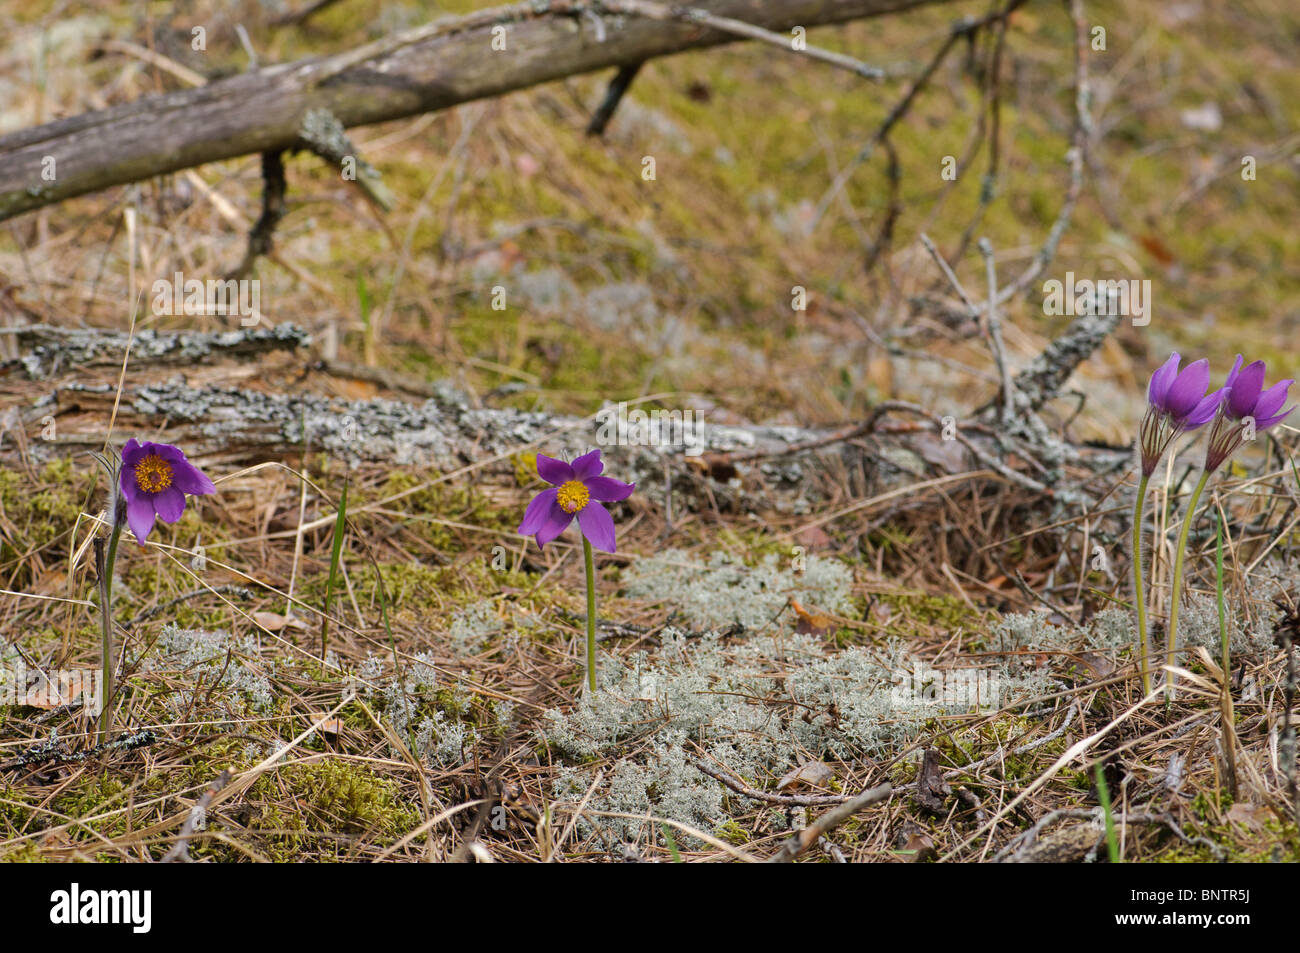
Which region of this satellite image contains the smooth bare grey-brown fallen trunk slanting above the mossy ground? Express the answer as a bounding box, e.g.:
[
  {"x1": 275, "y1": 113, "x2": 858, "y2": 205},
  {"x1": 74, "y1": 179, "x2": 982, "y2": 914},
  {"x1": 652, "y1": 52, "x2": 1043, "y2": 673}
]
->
[{"x1": 0, "y1": 0, "x2": 946, "y2": 220}]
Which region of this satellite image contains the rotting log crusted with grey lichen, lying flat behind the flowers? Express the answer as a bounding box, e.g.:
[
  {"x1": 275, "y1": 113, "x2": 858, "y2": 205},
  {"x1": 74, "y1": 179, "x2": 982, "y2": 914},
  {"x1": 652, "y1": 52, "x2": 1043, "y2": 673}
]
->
[{"x1": 0, "y1": 308, "x2": 1130, "y2": 510}]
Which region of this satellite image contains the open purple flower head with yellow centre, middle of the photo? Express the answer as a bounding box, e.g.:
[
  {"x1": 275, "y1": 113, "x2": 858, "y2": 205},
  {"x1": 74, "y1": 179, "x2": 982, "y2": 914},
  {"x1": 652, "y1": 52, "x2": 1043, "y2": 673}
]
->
[{"x1": 519, "y1": 450, "x2": 637, "y2": 553}]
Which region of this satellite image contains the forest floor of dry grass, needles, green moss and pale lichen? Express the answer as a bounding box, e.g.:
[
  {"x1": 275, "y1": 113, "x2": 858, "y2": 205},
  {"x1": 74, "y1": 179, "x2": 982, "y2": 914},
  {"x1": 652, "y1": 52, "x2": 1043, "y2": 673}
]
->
[{"x1": 0, "y1": 0, "x2": 1300, "y2": 862}]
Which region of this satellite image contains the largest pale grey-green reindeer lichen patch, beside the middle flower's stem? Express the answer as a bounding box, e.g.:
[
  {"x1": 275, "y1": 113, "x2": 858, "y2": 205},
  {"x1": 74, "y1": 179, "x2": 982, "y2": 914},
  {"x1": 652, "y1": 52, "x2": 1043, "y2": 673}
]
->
[{"x1": 540, "y1": 551, "x2": 1054, "y2": 839}]
